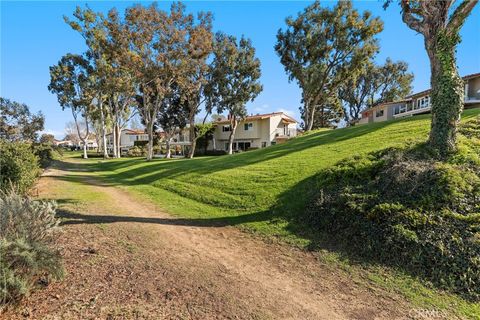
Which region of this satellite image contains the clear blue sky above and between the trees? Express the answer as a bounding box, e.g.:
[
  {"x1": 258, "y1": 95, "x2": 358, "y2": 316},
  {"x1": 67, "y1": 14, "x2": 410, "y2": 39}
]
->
[{"x1": 0, "y1": 1, "x2": 480, "y2": 138}]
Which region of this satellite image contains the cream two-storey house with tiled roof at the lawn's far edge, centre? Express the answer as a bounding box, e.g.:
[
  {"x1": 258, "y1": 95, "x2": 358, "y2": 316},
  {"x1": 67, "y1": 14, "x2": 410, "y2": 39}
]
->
[{"x1": 213, "y1": 112, "x2": 297, "y2": 151}]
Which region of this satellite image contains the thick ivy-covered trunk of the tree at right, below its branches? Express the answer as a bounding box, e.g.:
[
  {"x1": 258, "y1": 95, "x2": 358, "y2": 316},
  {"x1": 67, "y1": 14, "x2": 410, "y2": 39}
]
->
[{"x1": 425, "y1": 32, "x2": 464, "y2": 155}]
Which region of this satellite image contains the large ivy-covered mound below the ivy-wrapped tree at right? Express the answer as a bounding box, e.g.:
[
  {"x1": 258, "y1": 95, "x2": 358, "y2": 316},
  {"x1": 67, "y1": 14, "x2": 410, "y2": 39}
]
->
[{"x1": 307, "y1": 117, "x2": 480, "y2": 300}]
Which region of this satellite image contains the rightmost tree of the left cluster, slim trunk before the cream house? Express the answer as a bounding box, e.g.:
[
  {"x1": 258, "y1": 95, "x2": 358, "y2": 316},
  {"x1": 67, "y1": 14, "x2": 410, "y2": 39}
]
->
[{"x1": 206, "y1": 33, "x2": 263, "y2": 154}]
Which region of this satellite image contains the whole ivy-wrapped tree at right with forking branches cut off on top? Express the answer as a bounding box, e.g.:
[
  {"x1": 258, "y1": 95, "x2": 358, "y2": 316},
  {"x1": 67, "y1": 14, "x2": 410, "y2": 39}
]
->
[{"x1": 386, "y1": 0, "x2": 478, "y2": 154}]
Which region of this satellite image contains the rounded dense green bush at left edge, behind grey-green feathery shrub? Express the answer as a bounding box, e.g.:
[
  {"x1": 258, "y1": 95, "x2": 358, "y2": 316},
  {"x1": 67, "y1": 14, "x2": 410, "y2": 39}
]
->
[{"x1": 0, "y1": 140, "x2": 40, "y2": 194}]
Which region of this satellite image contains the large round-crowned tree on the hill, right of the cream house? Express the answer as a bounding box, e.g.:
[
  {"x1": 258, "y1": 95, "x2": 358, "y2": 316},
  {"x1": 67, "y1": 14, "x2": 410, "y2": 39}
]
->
[{"x1": 275, "y1": 1, "x2": 383, "y2": 130}]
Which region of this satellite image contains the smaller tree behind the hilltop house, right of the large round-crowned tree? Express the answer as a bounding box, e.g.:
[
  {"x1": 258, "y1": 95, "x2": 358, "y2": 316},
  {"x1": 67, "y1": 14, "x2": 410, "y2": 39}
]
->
[{"x1": 339, "y1": 58, "x2": 413, "y2": 125}]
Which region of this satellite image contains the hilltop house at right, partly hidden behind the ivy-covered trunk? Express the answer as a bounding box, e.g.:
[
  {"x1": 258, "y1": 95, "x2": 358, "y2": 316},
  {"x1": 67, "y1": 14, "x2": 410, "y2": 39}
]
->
[{"x1": 358, "y1": 73, "x2": 480, "y2": 124}]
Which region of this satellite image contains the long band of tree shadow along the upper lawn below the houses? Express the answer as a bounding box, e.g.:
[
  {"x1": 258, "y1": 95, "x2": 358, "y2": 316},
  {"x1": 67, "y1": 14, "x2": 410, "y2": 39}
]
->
[{"x1": 60, "y1": 119, "x2": 410, "y2": 185}]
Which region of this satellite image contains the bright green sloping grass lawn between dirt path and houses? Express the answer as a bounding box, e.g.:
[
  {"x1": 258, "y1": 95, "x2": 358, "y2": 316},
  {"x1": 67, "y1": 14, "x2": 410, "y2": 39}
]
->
[{"x1": 65, "y1": 109, "x2": 480, "y2": 318}]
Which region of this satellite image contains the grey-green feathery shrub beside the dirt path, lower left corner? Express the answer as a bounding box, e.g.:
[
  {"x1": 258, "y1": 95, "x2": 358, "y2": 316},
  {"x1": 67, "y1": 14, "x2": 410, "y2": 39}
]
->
[{"x1": 0, "y1": 191, "x2": 64, "y2": 303}]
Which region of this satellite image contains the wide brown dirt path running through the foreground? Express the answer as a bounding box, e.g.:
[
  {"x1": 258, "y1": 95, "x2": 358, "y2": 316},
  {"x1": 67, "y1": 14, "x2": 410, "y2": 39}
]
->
[{"x1": 0, "y1": 162, "x2": 416, "y2": 319}]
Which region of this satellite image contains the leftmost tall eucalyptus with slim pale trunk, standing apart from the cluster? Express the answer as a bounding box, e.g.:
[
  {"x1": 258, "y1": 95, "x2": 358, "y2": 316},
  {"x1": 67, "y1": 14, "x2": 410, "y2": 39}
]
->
[{"x1": 48, "y1": 54, "x2": 92, "y2": 158}]
